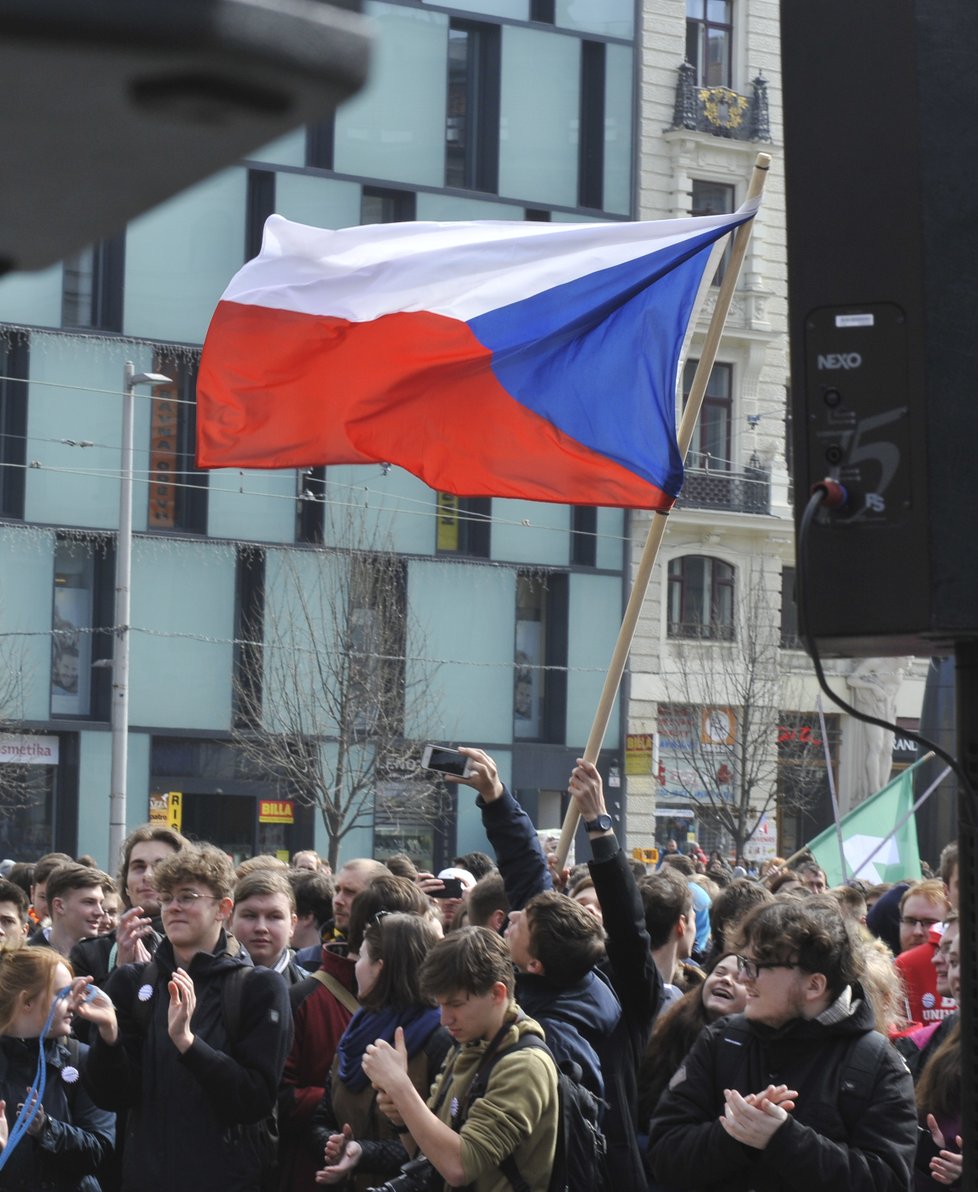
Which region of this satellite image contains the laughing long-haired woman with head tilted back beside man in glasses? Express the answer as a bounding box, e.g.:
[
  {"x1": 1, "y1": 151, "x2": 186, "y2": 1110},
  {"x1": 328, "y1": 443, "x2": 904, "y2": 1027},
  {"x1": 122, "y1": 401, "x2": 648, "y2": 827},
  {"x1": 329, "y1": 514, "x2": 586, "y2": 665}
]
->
[{"x1": 638, "y1": 952, "x2": 747, "y2": 1126}]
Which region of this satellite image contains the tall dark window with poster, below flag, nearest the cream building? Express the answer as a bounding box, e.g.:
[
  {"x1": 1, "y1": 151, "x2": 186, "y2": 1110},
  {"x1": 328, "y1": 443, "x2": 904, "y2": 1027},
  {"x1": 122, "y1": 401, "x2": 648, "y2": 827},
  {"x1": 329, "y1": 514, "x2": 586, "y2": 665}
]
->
[{"x1": 513, "y1": 573, "x2": 568, "y2": 741}]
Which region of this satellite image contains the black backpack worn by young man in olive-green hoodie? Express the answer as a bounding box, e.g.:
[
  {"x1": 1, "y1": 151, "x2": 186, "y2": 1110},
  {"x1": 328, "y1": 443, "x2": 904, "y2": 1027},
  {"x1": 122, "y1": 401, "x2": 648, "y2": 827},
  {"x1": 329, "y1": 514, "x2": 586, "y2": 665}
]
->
[{"x1": 466, "y1": 1035, "x2": 610, "y2": 1192}]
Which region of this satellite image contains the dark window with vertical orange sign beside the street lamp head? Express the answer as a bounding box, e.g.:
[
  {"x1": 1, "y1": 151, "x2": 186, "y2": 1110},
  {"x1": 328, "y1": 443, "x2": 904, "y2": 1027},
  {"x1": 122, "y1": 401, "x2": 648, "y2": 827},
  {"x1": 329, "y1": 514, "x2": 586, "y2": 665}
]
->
[{"x1": 147, "y1": 352, "x2": 208, "y2": 534}]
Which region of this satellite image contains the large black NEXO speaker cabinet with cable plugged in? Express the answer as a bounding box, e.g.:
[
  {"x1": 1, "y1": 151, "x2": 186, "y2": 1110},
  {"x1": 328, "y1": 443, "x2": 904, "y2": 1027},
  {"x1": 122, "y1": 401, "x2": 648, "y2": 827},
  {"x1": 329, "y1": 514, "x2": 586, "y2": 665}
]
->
[{"x1": 781, "y1": 0, "x2": 978, "y2": 656}]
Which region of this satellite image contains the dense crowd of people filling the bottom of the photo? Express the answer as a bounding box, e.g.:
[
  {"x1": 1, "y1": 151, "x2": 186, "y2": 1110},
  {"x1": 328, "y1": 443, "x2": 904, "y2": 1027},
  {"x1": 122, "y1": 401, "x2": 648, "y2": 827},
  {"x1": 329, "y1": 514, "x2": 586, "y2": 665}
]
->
[{"x1": 0, "y1": 749, "x2": 962, "y2": 1192}]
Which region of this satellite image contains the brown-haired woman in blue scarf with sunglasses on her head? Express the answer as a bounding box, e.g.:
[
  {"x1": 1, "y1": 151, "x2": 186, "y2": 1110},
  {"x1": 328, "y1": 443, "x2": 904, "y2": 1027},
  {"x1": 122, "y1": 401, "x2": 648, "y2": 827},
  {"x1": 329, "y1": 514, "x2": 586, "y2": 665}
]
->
[{"x1": 312, "y1": 911, "x2": 452, "y2": 1192}]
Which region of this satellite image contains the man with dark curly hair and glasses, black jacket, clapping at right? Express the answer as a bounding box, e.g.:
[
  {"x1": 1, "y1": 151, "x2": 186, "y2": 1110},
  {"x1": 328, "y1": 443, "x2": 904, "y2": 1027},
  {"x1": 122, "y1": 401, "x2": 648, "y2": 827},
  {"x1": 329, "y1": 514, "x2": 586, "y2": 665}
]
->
[{"x1": 649, "y1": 900, "x2": 917, "y2": 1192}]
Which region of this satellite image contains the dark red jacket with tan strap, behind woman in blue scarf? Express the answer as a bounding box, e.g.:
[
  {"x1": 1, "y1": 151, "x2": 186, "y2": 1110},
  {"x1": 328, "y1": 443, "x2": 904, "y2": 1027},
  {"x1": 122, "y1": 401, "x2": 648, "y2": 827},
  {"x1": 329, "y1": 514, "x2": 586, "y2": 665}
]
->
[{"x1": 278, "y1": 944, "x2": 355, "y2": 1192}]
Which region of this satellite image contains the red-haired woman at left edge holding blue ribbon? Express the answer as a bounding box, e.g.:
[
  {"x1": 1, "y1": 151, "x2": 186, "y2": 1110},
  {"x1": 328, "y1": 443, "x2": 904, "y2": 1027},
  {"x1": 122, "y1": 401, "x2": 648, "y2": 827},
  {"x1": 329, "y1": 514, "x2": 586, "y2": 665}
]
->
[{"x1": 0, "y1": 948, "x2": 116, "y2": 1192}]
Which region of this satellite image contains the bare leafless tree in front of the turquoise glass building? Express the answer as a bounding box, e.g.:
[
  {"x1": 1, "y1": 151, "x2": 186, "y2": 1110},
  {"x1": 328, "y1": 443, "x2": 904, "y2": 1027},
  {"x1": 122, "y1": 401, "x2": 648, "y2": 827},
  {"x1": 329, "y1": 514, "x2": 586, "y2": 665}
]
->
[{"x1": 233, "y1": 503, "x2": 445, "y2": 864}]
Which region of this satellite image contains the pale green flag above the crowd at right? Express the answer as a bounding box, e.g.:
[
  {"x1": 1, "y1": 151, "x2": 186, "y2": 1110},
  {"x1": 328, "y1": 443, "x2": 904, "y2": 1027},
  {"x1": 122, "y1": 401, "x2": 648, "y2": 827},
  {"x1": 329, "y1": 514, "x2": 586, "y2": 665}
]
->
[{"x1": 807, "y1": 763, "x2": 921, "y2": 886}]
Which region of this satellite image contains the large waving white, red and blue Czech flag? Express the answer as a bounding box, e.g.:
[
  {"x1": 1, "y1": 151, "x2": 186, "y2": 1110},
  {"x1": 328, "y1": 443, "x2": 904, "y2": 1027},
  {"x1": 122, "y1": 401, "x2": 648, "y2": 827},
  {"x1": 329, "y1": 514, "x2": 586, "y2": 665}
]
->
[{"x1": 197, "y1": 201, "x2": 757, "y2": 510}]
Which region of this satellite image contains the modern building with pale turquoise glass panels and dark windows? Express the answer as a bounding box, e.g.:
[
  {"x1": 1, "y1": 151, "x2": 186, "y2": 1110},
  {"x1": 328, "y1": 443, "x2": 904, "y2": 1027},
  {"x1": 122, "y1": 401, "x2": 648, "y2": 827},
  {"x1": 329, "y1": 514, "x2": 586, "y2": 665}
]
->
[{"x1": 0, "y1": 0, "x2": 637, "y2": 867}]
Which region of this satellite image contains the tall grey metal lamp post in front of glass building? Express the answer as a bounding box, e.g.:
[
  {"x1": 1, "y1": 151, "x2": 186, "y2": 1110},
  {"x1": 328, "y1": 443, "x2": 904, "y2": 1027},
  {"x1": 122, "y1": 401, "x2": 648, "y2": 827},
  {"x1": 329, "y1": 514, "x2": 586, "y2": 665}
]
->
[{"x1": 109, "y1": 360, "x2": 169, "y2": 868}]
